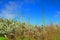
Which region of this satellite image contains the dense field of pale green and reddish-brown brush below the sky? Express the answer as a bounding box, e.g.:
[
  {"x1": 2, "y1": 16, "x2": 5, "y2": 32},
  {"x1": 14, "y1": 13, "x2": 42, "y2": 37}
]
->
[{"x1": 0, "y1": 18, "x2": 60, "y2": 40}]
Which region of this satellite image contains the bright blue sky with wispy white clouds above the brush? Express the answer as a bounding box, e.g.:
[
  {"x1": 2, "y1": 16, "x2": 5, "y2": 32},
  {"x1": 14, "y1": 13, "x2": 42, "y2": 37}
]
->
[{"x1": 0, "y1": 0, "x2": 60, "y2": 25}]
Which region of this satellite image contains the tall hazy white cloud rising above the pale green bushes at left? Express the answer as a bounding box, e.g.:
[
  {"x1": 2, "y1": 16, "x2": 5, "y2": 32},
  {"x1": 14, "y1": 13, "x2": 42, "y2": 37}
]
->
[{"x1": 0, "y1": 1, "x2": 17, "y2": 19}]
